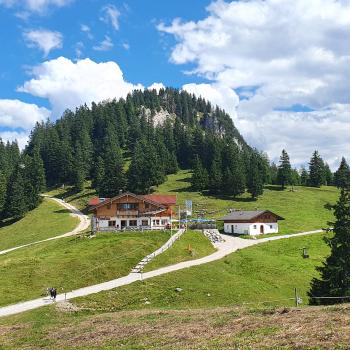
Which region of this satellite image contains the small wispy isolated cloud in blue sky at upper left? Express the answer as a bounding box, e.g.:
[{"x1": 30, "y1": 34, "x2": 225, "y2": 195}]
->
[{"x1": 23, "y1": 29, "x2": 63, "y2": 57}]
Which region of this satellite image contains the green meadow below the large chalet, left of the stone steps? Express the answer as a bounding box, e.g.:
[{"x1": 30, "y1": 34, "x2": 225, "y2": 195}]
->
[{"x1": 0, "y1": 231, "x2": 169, "y2": 306}]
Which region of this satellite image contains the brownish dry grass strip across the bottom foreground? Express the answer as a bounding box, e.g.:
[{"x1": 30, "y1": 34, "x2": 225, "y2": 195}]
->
[{"x1": 0, "y1": 305, "x2": 350, "y2": 350}]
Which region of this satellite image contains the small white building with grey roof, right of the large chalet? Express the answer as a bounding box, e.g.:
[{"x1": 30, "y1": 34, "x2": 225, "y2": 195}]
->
[{"x1": 221, "y1": 210, "x2": 284, "y2": 236}]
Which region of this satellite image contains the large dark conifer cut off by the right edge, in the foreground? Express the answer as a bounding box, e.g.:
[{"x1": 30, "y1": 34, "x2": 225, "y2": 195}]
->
[{"x1": 309, "y1": 188, "x2": 350, "y2": 304}]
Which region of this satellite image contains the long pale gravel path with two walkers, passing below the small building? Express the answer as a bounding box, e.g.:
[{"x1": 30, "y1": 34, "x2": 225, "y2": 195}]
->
[{"x1": 0, "y1": 230, "x2": 322, "y2": 317}]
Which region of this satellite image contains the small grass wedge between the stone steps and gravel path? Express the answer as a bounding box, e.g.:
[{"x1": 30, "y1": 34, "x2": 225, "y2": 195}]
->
[{"x1": 144, "y1": 230, "x2": 215, "y2": 271}]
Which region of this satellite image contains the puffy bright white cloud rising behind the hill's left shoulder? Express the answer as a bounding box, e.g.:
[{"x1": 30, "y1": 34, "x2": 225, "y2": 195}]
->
[{"x1": 18, "y1": 57, "x2": 143, "y2": 118}]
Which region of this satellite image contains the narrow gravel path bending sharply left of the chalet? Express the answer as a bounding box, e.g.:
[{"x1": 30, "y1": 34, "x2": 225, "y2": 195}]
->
[{"x1": 0, "y1": 196, "x2": 90, "y2": 255}]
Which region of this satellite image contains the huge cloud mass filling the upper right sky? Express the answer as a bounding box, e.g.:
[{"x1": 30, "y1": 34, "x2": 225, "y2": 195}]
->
[{"x1": 158, "y1": 0, "x2": 350, "y2": 168}]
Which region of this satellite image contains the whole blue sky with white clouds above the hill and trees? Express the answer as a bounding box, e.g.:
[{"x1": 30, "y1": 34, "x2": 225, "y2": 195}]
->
[{"x1": 0, "y1": 0, "x2": 350, "y2": 168}]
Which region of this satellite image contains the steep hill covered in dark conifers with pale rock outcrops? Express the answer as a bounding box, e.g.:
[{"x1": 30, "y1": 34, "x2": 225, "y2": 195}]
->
[{"x1": 25, "y1": 88, "x2": 269, "y2": 197}]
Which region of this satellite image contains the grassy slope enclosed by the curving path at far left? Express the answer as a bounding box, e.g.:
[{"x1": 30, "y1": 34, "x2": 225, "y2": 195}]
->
[{"x1": 0, "y1": 199, "x2": 79, "y2": 250}]
